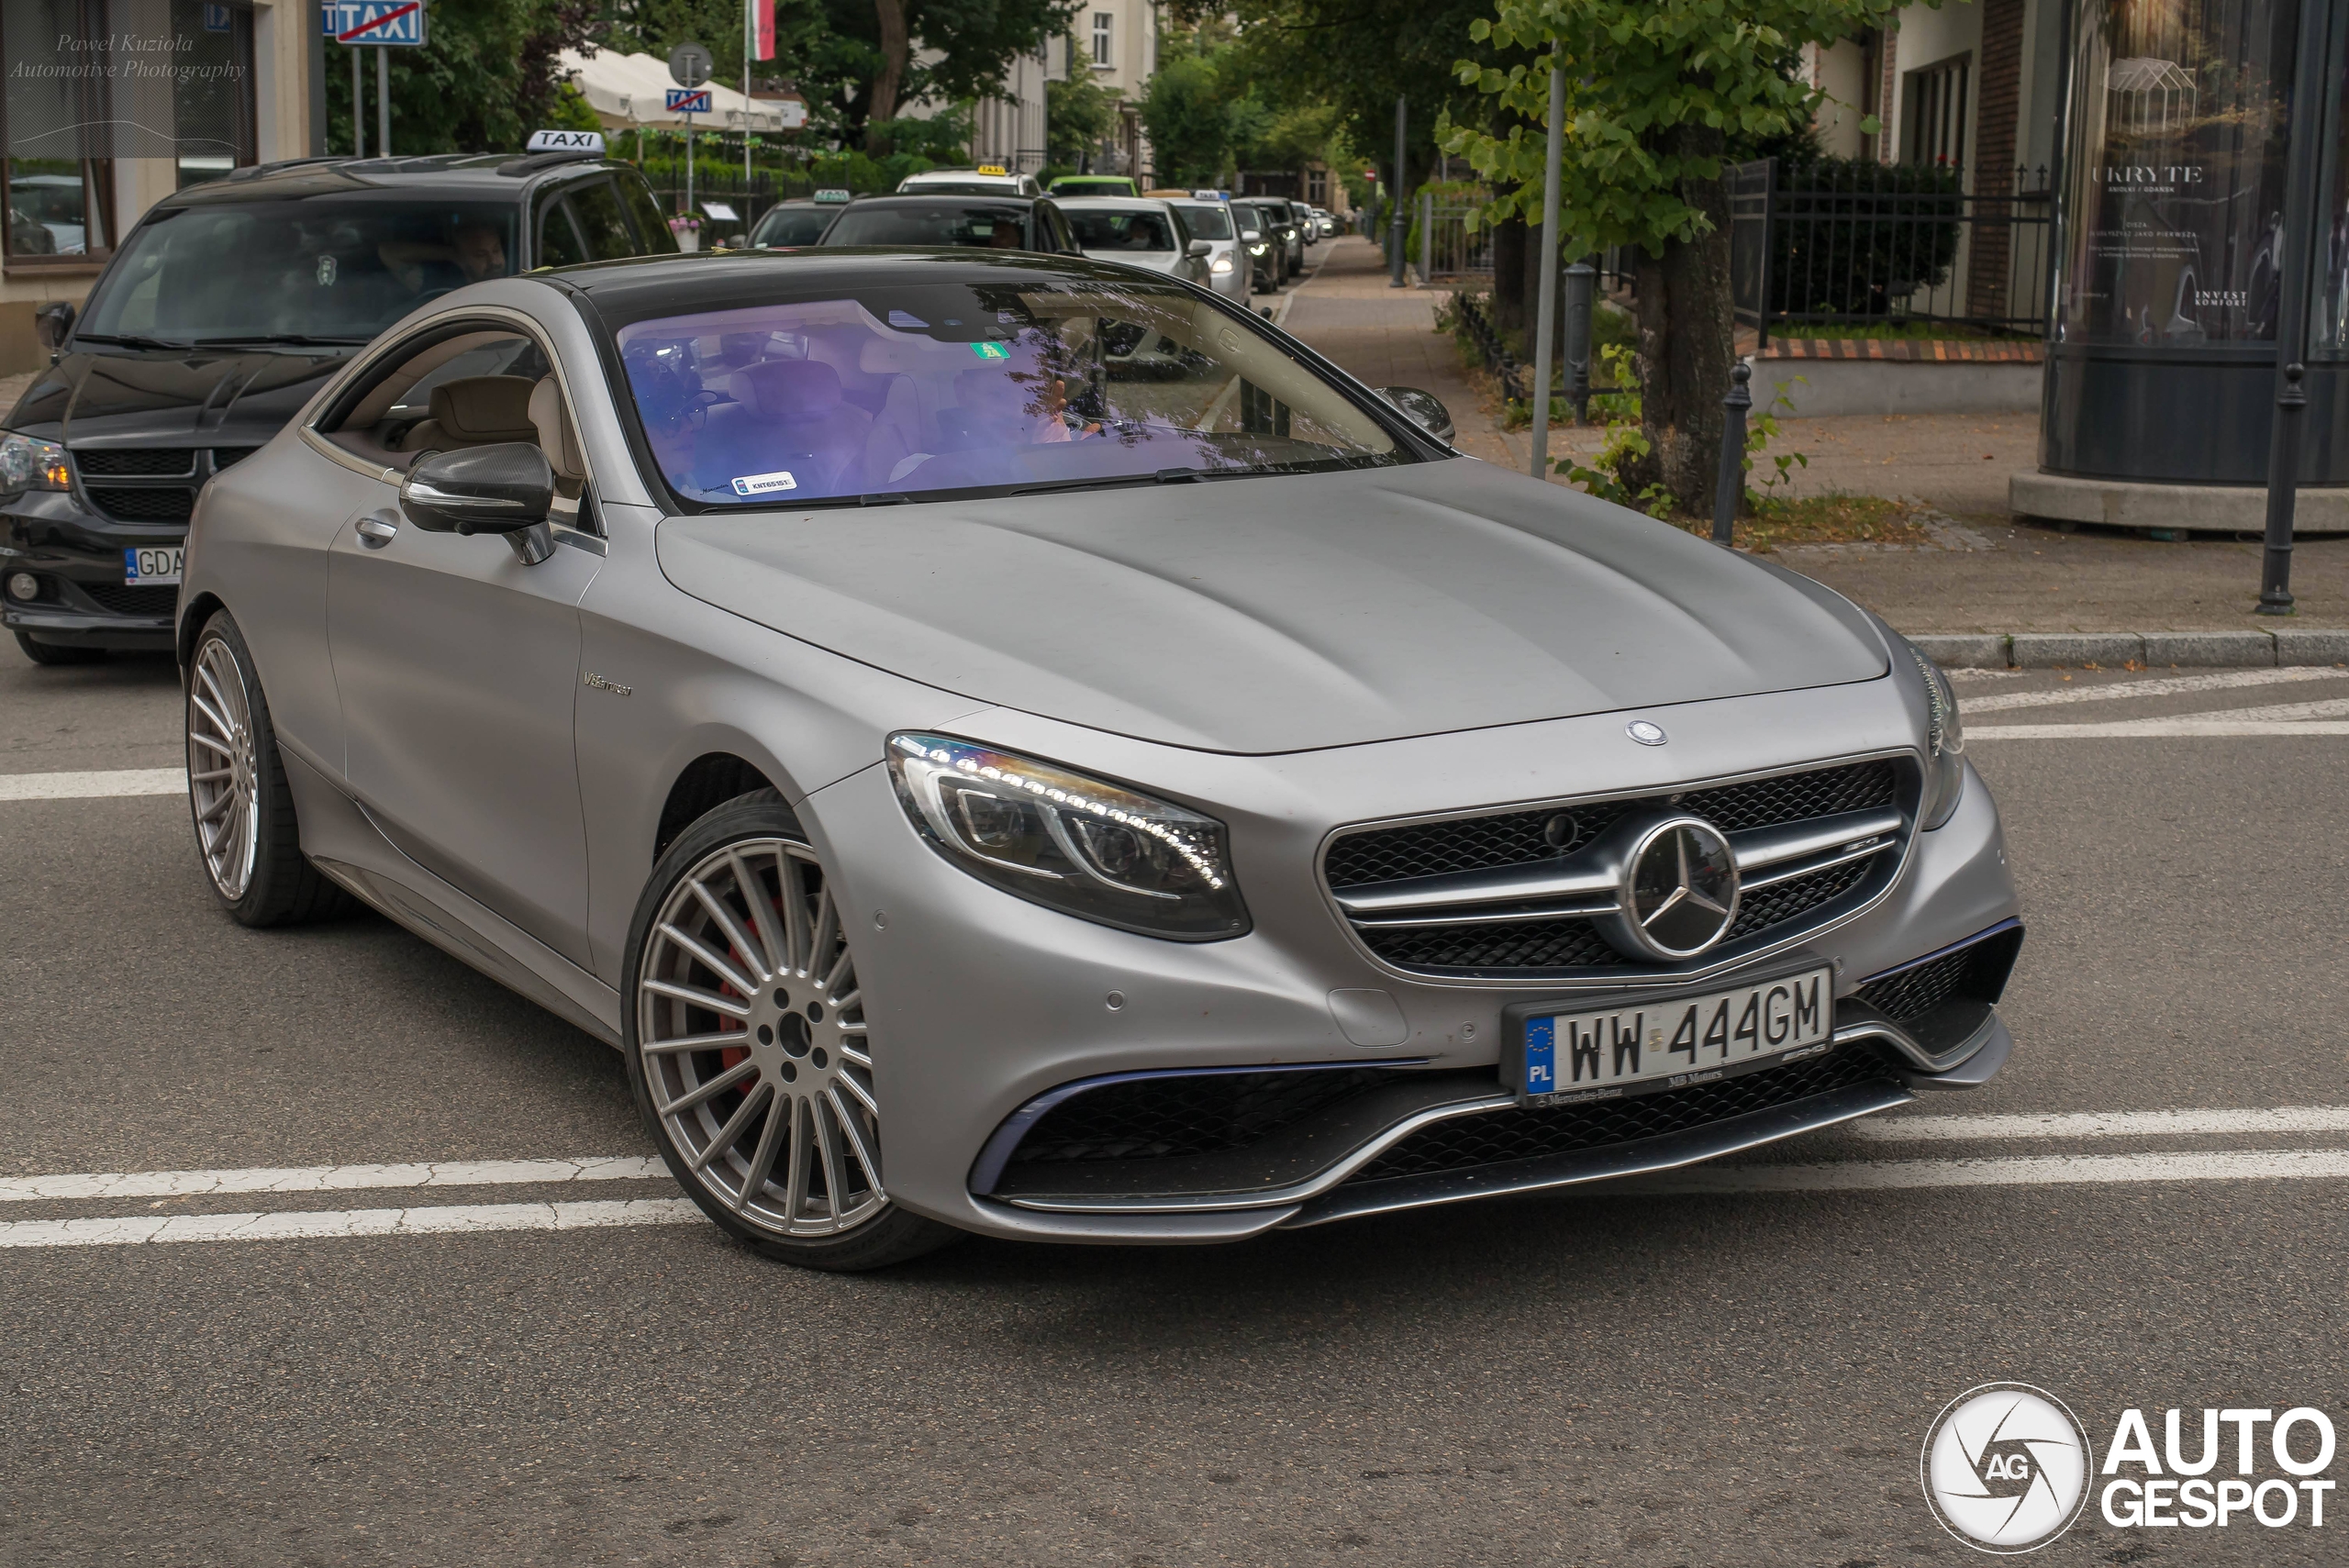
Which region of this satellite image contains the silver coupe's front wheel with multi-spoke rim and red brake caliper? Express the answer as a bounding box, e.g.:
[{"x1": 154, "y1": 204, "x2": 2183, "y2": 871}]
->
[{"x1": 622, "y1": 789, "x2": 956, "y2": 1273}]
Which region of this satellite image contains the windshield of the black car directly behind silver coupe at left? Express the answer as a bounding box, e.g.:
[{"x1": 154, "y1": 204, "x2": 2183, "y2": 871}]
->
[{"x1": 75, "y1": 199, "x2": 515, "y2": 343}]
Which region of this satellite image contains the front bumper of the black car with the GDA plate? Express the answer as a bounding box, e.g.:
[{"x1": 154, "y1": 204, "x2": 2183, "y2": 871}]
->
[{"x1": 0, "y1": 491, "x2": 188, "y2": 652}]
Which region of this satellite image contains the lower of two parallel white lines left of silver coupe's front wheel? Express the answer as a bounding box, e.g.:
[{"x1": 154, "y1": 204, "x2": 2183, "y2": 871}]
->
[{"x1": 0, "y1": 1197, "x2": 707, "y2": 1249}]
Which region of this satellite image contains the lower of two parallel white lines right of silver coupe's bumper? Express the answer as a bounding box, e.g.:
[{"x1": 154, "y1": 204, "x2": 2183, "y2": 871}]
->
[{"x1": 1609, "y1": 1148, "x2": 2349, "y2": 1193}]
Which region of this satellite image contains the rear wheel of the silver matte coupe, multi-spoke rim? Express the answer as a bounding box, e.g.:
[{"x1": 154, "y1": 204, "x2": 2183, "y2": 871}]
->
[{"x1": 185, "y1": 610, "x2": 352, "y2": 928}]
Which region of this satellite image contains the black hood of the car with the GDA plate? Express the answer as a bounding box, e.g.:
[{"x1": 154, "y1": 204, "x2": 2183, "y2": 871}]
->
[{"x1": 7, "y1": 348, "x2": 357, "y2": 446}]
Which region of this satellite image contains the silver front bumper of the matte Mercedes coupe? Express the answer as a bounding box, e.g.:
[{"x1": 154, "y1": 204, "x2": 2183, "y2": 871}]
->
[{"x1": 801, "y1": 695, "x2": 2021, "y2": 1241}]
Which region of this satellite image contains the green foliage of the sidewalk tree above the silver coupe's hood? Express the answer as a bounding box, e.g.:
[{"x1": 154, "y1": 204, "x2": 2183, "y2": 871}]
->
[{"x1": 1442, "y1": 0, "x2": 1898, "y2": 258}]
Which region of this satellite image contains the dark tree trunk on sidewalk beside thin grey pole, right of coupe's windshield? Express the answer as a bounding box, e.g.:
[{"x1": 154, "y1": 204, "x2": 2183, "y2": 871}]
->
[{"x1": 1626, "y1": 127, "x2": 1736, "y2": 517}]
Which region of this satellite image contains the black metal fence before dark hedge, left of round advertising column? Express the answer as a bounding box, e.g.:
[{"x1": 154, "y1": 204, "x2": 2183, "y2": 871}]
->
[{"x1": 1729, "y1": 157, "x2": 2051, "y2": 345}]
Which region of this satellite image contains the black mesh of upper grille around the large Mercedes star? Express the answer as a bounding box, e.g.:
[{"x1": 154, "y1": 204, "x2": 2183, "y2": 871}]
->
[{"x1": 1322, "y1": 758, "x2": 1909, "y2": 976}]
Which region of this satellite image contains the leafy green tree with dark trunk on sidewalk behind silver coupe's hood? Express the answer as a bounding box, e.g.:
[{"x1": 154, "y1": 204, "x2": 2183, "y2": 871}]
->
[{"x1": 1444, "y1": 0, "x2": 1896, "y2": 514}]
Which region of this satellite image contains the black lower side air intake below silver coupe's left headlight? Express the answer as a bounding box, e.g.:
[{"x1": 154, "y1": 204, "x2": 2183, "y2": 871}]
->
[{"x1": 1010, "y1": 1068, "x2": 1393, "y2": 1164}]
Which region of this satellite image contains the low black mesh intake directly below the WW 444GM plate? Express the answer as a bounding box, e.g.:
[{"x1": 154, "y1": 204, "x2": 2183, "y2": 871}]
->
[{"x1": 1348, "y1": 1044, "x2": 1893, "y2": 1183}]
